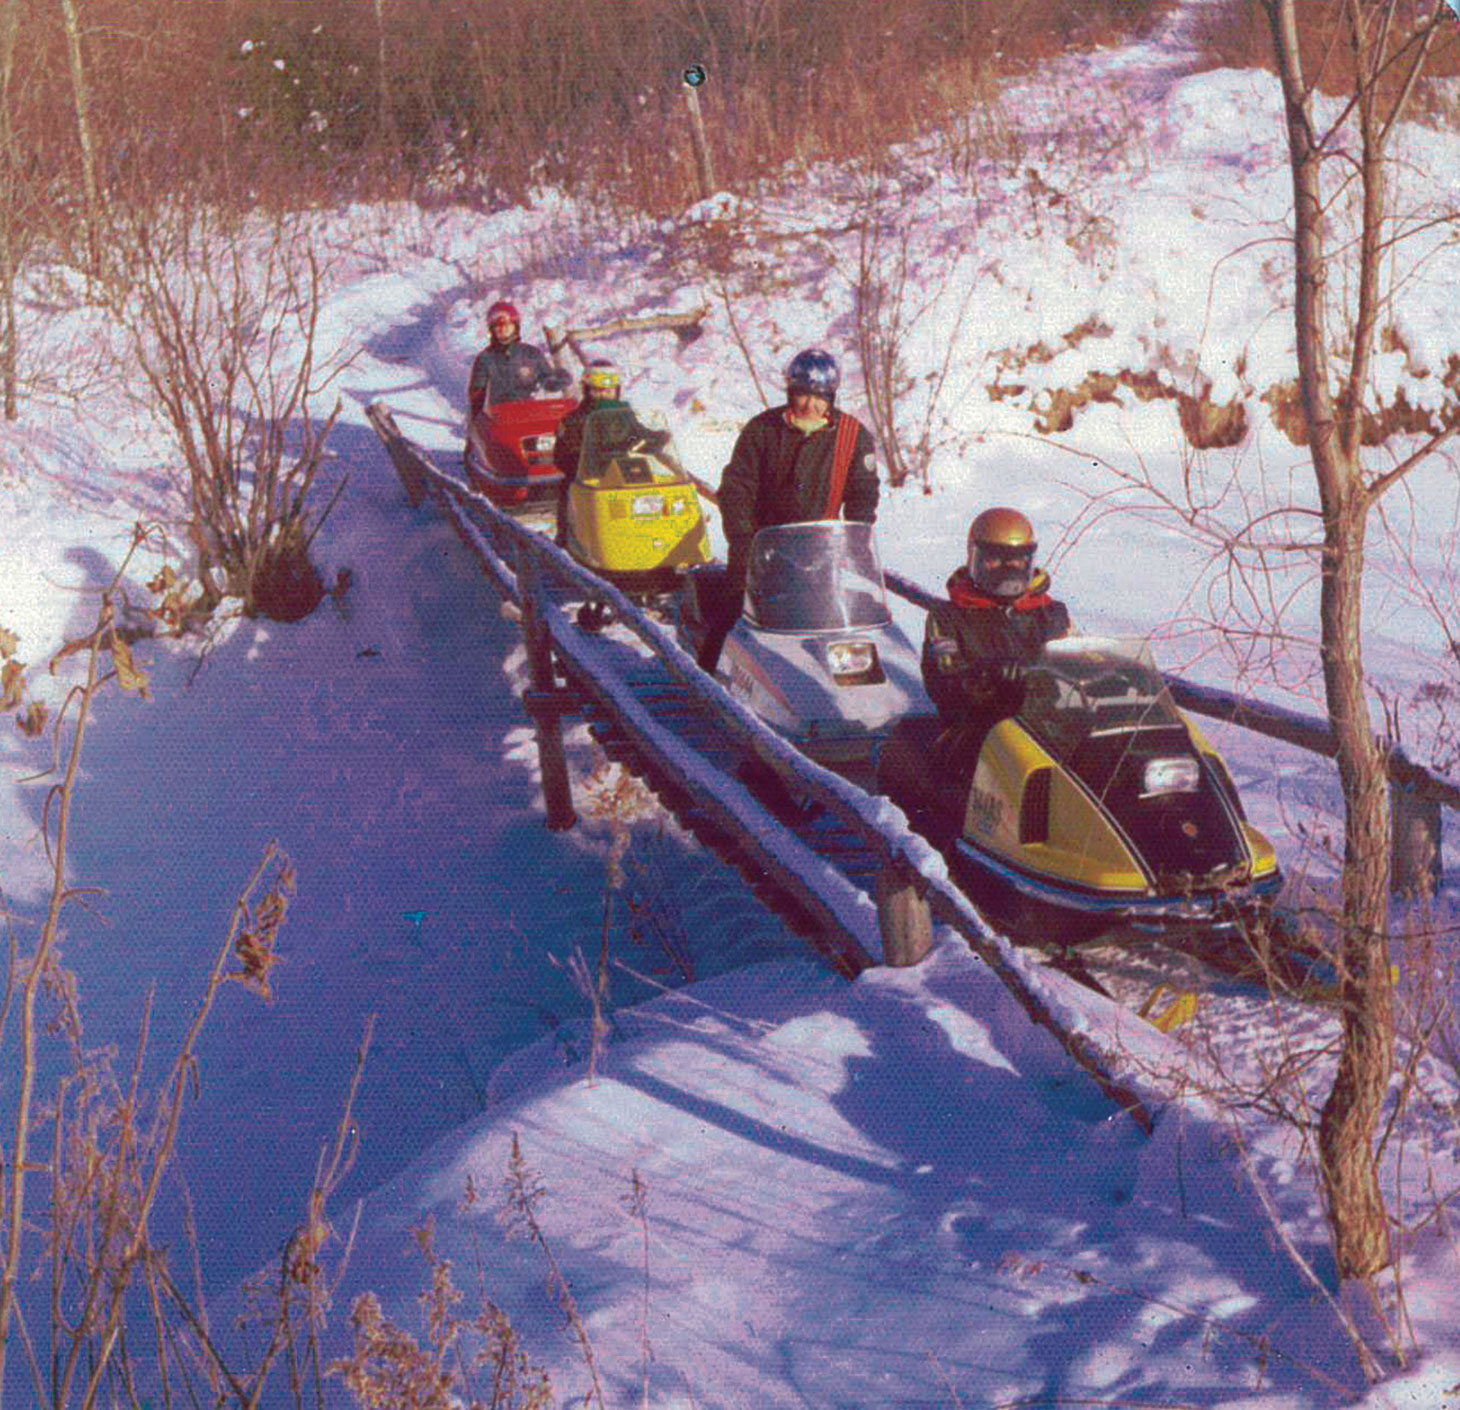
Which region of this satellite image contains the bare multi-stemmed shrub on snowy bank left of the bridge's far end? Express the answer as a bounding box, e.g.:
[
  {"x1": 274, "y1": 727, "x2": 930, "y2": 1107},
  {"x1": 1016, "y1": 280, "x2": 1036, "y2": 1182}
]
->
[{"x1": 114, "y1": 201, "x2": 343, "y2": 620}]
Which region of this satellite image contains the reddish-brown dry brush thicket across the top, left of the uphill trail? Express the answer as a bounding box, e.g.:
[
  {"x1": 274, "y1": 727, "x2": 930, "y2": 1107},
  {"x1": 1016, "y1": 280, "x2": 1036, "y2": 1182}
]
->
[{"x1": 5, "y1": 0, "x2": 1171, "y2": 226}]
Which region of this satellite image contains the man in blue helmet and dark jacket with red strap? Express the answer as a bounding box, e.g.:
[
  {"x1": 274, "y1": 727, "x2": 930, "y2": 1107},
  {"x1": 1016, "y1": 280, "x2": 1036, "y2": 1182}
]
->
[{"x1": 699, "y1": 347, "x2": 877, "y2": 671}]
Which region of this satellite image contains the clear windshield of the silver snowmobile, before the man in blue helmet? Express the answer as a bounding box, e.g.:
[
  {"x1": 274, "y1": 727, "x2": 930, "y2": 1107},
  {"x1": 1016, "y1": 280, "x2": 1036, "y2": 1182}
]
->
[{"x1": 745, "y1": 520, "x2": 892, "y2": 632}]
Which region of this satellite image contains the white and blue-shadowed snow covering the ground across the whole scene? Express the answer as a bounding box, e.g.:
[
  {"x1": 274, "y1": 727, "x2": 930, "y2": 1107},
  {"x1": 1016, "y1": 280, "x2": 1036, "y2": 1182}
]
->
[{"x1": 0, "y1": 13, "x2": 1460, "y2": 1410}]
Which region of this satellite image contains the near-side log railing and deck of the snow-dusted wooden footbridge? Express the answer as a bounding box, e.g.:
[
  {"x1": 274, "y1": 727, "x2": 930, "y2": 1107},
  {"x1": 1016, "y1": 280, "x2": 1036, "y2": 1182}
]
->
[{"x1": 368, "y1": 403, "x2": 1153, "y2": 1131}]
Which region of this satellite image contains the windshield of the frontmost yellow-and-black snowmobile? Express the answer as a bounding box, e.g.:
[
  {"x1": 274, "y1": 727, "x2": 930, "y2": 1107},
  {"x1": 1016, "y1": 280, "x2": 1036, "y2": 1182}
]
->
[{"x1": 1021, "y1": 636, "x2": 1186, "y2": 759}]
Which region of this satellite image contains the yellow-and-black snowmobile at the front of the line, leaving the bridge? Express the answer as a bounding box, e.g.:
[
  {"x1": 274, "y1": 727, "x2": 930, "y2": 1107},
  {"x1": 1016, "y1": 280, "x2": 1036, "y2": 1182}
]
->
[{"x1": 877, "y1": 636, "x2": 1282, "y2": 946}]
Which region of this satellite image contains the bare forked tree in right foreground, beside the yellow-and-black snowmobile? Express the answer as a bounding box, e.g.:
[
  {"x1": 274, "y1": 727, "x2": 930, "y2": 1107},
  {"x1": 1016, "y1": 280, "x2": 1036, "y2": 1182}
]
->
[{"x1": 1263, "y1": 0, "x2": 1453, "y2": 1277}]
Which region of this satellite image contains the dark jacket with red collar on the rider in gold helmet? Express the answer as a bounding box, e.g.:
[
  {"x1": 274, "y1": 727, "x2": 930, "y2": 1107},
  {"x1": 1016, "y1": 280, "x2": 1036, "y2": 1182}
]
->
[{"x1": 923, "y1": 568, "x2": 1070, "y2": 720}]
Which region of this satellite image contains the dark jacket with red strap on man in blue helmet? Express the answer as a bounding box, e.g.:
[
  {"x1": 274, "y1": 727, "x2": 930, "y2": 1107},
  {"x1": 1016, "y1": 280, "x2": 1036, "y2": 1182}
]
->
[{"x1": 720, "y1": 406, "x2": 877, "y2": 585}]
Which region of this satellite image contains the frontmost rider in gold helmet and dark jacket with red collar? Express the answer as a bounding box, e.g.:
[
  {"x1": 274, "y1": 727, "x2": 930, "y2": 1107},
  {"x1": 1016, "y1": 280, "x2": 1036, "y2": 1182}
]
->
[{"x1": 923, "y1": 506, "x2": 1070, "y2": 720}]
